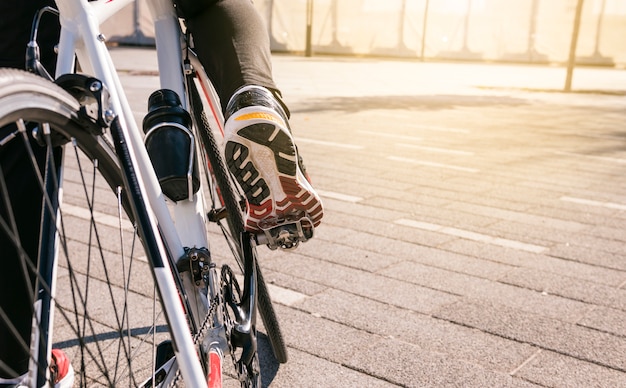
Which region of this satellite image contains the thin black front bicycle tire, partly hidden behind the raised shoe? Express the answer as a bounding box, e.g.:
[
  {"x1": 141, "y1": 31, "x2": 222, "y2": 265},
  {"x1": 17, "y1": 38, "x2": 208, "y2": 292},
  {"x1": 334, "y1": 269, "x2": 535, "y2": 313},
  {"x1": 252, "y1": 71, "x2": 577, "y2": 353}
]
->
[{"x1": 188, "y1": 76, "x2": 288, "y2": 364}]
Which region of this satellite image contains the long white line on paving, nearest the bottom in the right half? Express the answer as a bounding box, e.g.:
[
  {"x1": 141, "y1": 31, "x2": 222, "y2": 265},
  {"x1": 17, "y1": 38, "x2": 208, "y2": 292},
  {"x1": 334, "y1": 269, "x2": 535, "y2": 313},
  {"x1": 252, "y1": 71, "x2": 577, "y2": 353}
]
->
[{"x1": 394, "y1": 219, "x2": 548, "y2": 253}]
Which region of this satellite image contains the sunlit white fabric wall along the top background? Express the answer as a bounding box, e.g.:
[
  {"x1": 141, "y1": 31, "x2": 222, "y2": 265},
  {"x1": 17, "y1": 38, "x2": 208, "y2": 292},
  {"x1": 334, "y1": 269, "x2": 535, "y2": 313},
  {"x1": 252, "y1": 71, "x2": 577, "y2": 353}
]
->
[{"x1": 105, "y1": 0, "x2": 626, "y2": 67}]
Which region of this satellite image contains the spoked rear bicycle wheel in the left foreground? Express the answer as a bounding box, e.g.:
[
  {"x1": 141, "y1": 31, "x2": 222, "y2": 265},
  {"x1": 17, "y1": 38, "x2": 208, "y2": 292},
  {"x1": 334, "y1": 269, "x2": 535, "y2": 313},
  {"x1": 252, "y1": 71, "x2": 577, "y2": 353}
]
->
[{"x1": 0, "y1": 69, "x2": 197, "y2": 387}]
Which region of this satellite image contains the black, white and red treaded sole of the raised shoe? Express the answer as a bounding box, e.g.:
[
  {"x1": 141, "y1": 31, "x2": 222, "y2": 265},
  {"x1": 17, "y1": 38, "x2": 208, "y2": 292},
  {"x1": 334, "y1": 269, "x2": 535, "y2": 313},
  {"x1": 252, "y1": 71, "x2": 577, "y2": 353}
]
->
[{"x1": 226, "y1": 122, "x2": 323, "y2": 232}]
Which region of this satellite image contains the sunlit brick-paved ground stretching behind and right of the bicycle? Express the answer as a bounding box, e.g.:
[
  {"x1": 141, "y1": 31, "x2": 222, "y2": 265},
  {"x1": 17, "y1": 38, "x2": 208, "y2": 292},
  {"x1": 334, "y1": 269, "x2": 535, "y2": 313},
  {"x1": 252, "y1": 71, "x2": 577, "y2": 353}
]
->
[{"x1": 113, "y1": 49, "x2": 626, "y2": 387}]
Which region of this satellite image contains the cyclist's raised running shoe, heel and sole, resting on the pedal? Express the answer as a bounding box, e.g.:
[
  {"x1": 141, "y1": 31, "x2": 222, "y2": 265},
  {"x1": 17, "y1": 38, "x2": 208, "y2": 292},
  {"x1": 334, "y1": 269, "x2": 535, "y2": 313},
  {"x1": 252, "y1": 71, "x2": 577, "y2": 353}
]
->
[{"x1": 225, "y1": 86, "x2": 323, "y2": 232}]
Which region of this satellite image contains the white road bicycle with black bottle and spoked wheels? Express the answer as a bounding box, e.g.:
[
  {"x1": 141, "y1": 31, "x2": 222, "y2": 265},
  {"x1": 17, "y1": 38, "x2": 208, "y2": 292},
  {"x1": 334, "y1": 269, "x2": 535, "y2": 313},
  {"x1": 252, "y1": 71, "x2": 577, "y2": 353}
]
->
[{"x1": 0, "y1": 0, "x2": 313, "y2": 387}]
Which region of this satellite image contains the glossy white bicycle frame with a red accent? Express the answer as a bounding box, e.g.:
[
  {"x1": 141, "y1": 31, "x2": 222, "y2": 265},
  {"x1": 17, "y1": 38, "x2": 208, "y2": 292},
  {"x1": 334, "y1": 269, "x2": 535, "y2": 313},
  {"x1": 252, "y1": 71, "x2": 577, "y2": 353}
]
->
[{"x1": 48, "y1": 0, "x2": 223, "y2": 387}]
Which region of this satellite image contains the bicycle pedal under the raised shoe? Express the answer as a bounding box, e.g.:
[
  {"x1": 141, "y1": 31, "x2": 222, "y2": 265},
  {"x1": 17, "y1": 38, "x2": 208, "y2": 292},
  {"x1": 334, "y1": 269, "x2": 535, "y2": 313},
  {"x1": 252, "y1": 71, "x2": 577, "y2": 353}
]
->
[{"x1": 256, "y1": 213, "x2": 313, "y2": 250}]
